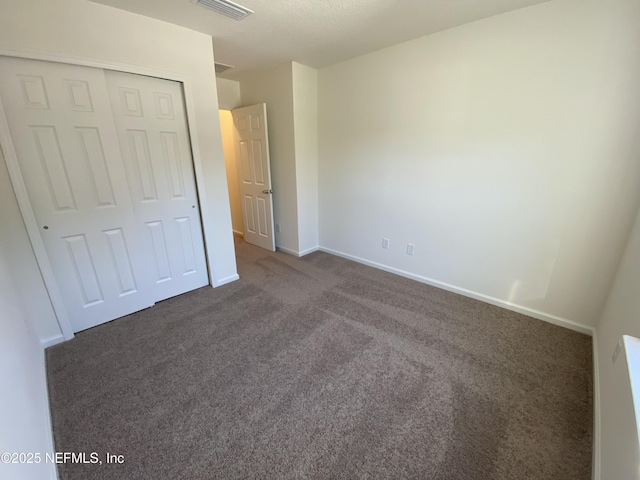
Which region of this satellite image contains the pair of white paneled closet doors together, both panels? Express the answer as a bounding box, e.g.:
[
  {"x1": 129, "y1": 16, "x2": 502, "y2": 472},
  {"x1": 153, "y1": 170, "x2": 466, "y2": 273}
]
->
[{"x1": 0, "y1": 57, "x2": 208, "y2": 331}]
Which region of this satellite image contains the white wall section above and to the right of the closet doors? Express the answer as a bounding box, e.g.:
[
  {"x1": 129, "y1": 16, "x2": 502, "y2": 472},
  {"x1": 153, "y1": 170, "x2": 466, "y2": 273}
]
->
[{"x1": 0, "y1": 0, "x2": 237, "y2": 339}]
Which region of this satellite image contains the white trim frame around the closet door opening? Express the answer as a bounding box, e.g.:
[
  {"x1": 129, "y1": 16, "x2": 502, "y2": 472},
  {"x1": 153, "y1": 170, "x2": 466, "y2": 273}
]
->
[{"x1": 0, "y1": 48, "x2": 215, "y2": 340}]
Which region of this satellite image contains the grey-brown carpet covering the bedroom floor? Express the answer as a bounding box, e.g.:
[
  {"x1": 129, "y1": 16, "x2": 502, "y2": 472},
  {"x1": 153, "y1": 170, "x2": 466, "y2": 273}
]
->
[{"x1": 47, "y1": 238, "x2": 593, "y2": 480}]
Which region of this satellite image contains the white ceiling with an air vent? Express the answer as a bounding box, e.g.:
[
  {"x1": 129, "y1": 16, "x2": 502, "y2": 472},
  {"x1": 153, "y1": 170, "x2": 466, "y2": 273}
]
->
[{"x1": 92, "y1": 0, "x2": 549, "y2": 78}]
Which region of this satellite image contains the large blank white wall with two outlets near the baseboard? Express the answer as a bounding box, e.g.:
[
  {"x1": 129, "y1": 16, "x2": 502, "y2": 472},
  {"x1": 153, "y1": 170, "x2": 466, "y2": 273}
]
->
[{"x1": 319, "y1": 0, "x2": 640, "y2": 326}]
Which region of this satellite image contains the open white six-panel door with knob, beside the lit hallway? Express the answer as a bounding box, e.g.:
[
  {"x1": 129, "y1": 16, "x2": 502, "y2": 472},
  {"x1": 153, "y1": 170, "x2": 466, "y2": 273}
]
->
[{"x1": 231, "y1": 103, "x2": 276, "y2": 252}]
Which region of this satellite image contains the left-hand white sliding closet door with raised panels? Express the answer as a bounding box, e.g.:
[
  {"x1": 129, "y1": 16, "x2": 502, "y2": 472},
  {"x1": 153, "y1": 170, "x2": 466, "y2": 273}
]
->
[{"x1": 0, "y1": 57, "x2": 154, "y2": 331}]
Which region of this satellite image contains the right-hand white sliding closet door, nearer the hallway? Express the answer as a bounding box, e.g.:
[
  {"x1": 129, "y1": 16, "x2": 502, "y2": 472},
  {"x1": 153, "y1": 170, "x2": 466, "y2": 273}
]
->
[{"x1": 106, "y1": 71, "x2": 209, "y2": 301}]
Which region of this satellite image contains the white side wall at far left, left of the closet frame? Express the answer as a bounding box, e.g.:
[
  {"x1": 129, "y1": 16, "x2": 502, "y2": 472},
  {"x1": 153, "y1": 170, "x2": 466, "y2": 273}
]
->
[{"x1": 0, "y1": 238, "x2": 56, "y2": 480}]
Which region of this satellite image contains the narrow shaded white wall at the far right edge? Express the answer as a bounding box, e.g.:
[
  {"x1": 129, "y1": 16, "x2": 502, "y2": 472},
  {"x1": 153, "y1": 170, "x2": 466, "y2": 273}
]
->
[{"x1": 596, "y1": 204, "x2": 640, "y2": 480}]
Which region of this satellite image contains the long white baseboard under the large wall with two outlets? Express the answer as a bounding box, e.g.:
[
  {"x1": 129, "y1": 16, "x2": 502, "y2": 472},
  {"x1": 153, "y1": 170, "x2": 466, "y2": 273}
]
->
[{"x1": 319, "y1": 246, "x2": 595, "y2": 336}]
